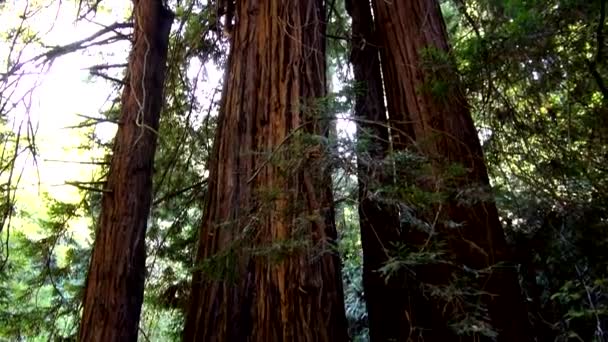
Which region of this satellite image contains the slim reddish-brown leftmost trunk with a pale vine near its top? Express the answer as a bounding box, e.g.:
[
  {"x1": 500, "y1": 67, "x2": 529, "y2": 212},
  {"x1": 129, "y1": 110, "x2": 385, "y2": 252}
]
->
[{"x1": 79, "y1": 0, "x2": 173, "y2": 342}]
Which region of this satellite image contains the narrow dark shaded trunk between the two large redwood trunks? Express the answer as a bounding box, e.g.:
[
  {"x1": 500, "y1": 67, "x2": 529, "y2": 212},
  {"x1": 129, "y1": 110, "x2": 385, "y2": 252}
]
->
[{"x1": 346, "y1": 0, "x2": 408, "y2": 341}]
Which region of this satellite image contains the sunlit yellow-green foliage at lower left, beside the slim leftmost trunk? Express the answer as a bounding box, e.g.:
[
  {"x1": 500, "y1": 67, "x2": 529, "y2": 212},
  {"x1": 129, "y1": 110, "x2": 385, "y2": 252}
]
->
[{"x1": 0, "y1": 199, "x2": 88, "y2": 339}]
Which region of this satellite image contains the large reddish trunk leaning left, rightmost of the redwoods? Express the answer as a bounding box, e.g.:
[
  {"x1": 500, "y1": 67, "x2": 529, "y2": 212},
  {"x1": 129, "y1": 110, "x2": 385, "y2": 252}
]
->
[{"x1": 365, "y1": 0, "x2": 528, "y2": 341}]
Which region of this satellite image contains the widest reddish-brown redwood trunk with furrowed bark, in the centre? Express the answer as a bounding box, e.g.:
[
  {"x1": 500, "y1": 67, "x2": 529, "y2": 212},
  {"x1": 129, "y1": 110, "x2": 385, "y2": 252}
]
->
[{"x1": 184, "y1": 0, "x2": 347, "y2": 342}]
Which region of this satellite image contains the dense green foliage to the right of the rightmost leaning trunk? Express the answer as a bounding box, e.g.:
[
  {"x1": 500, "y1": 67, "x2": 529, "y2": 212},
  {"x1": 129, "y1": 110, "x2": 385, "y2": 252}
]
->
[{"x1": 447, "y1": 0, "x2": 608, "y2": 341}]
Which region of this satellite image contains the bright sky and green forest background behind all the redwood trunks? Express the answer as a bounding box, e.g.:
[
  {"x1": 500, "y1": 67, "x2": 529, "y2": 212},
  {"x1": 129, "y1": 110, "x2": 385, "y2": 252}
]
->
[{"x1": 0, "y1": 0, "x2": 608, "y2": 341}]
